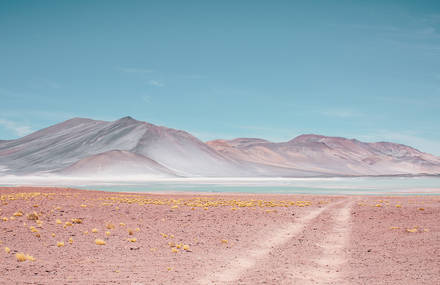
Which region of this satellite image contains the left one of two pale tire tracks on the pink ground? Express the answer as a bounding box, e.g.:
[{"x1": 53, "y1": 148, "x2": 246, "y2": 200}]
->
[{"x1": 199, "y1": 202, "x2": 341, "y2": 284}]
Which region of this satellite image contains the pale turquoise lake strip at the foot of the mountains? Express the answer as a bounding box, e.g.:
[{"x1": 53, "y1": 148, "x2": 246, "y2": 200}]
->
[{"x1": 72, "y1": 176, "x2": 440, "y2": 195}]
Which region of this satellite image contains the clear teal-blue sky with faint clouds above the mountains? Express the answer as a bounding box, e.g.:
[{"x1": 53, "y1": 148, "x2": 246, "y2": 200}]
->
[{"x1": 0, "y1": 0, "x2": 440, "y2": 155}]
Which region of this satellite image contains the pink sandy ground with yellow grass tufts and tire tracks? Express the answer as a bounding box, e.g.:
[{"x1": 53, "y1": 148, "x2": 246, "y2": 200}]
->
[{"x1": 0, "y1": 187, "x2": 440, "y2": 284}]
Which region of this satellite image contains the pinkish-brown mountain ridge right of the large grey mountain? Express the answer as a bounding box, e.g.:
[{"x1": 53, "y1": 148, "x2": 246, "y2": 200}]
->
[{"x1": 207, "y1": 135, "x2": 440, "y2": 175}]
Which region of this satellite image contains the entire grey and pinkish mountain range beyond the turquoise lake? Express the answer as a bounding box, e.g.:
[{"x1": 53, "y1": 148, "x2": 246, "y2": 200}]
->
[{"x1": 0, "y1": 117, "x2": 440, "y2": 178}]
